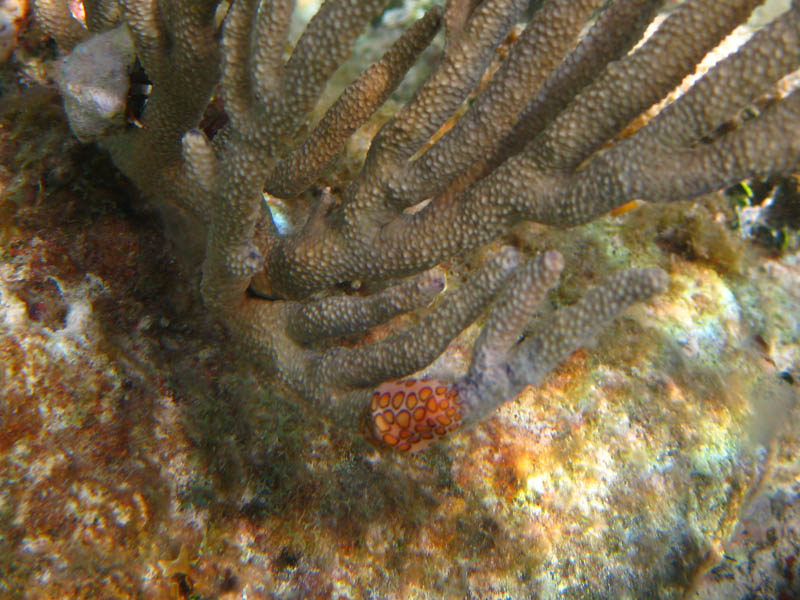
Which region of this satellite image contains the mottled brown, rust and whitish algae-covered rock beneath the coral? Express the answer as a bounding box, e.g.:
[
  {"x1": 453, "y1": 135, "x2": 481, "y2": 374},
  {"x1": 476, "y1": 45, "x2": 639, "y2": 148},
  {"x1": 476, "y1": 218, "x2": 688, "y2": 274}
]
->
[{"x1": 0, "y1": 4, "x2": 800, "y2": 600}]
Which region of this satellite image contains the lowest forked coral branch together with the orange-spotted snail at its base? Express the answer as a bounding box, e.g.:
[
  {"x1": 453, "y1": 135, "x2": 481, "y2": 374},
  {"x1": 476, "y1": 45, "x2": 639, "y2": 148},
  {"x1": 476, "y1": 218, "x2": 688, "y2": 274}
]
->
[{"x1": 362, "y1": 252, "x2": 667, "y2": 452}]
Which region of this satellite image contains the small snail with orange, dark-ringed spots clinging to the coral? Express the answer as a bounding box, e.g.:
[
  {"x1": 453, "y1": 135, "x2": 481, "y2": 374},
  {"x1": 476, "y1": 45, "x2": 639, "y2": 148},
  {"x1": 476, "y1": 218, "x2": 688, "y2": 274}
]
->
[{"x1": 364, "y1": 379, "x2": 463, "y2": 452}]
